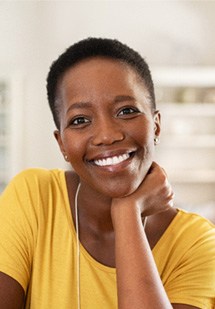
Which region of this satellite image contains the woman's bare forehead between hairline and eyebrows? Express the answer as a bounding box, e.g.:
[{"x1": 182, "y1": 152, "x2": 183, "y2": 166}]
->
[{"x1": 57, "y1": 57, "x2": 151, "y2": 110}]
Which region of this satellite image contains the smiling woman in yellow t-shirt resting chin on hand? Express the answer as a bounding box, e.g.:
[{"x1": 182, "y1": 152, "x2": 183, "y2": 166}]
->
[{"x1": 0, "y1": 38, "x2": 215, "y2": 309}]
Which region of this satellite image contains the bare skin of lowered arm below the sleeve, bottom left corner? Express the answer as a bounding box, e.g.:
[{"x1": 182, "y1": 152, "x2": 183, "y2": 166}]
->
[{"x1": 0, "y1": 272, "x2": 24, "y2": 309}]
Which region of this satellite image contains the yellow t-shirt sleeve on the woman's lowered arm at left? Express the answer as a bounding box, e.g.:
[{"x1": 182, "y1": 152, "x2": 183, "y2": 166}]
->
[{"x1": 0, "y1": 170, "x2": 37, "y2": 292}]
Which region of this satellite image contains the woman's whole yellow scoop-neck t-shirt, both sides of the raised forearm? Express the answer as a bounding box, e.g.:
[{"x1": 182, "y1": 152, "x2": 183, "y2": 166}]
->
[{"x1": 0, "y1": 169, "x2": 215, "y2": 309}]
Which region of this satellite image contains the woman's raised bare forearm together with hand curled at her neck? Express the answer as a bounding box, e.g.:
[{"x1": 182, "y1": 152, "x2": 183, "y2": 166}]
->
[{"x1": 111, "y1": 164, "x2": 200, "y2": 309}]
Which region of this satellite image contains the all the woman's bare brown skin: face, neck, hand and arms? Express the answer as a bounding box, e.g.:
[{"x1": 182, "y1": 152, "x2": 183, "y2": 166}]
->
[{"x1": 0, "y1": 58, "x2": 200, "y2": 309}]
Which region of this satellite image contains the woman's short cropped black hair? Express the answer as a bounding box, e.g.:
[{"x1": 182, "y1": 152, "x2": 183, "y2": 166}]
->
[{"x1": 47, "y1": 38, "x2": 156, "y2": 129}]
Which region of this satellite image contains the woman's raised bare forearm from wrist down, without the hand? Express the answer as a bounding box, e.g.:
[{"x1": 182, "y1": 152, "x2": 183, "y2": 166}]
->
[{"x1": 112, "y1": 205, "x2": 172, "y2": 309}]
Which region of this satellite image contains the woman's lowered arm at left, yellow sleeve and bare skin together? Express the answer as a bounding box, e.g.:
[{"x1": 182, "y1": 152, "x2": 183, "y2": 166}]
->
[{"x1": 0, "y1": 172, "x2": 36, "y2": 309}]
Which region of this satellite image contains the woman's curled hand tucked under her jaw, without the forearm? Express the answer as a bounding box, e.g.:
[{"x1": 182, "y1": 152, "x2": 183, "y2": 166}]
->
[{"x1": 112, "y1": 162, "x2": 174, "y2": 217}]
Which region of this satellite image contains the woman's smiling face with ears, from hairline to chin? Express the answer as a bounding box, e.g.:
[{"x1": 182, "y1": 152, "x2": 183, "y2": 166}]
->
[{"x1": 55, "y1": 57, "x2": 160, "y2": 197}]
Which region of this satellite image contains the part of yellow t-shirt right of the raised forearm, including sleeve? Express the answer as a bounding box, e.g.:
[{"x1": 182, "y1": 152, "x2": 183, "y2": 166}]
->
[{"x1": 155, "y1": 211, "x2": 215, "y2": 309}]
